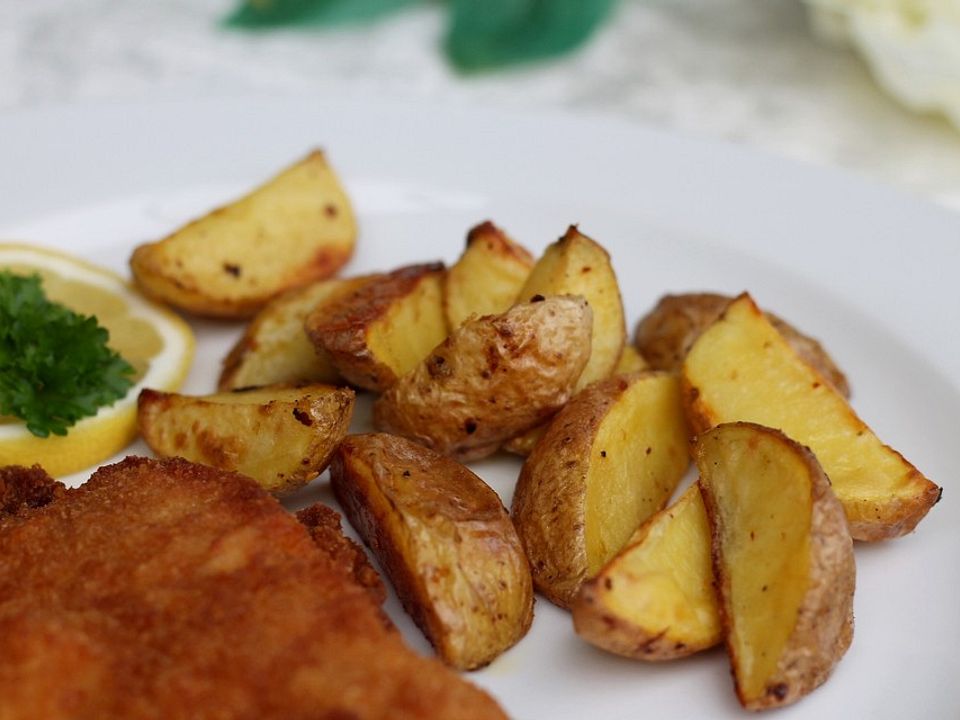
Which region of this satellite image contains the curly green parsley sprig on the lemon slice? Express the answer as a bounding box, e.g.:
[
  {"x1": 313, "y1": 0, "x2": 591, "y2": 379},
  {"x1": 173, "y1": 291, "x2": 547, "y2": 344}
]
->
[{"x1": 0, "y1": 271, "x2": 134, "y2": 437}]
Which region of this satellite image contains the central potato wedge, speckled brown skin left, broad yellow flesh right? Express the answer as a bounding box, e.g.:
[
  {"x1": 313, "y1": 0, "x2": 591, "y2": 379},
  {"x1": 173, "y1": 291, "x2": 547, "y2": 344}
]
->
[{"x1": 513, "y1": 372, "x2": 690, "y2": 607}]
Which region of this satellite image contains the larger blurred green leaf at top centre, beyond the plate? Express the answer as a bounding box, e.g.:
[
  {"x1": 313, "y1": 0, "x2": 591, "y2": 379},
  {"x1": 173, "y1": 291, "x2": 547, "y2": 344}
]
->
[{"x1": 446, "y1": 0, "x2": 616, "y2": 70}]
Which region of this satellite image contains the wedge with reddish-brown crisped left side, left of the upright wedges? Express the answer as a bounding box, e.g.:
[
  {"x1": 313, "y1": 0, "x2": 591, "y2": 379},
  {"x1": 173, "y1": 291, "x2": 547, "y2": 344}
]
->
[{"x1": 304, "y1": 263, "x2": 447, "y2": 392}]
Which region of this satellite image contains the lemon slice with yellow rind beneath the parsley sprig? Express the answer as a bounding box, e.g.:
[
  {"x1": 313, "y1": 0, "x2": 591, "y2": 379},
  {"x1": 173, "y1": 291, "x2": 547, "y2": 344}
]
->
[{"x1": 0, "y1": 243, "x2": 194, "y2": 477}]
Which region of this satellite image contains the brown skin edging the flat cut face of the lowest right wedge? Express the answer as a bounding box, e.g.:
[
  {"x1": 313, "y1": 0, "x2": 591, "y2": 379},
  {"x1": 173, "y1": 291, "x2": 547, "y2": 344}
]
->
[{"x1": 696, "y1": 422, "x2": 856, "y2": 710}]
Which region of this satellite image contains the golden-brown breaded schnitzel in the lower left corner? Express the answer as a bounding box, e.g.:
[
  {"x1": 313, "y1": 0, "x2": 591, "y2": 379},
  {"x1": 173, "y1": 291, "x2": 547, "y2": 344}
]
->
[{"x1": 0, "y1": 458, "x2": 506, "y2": 720}]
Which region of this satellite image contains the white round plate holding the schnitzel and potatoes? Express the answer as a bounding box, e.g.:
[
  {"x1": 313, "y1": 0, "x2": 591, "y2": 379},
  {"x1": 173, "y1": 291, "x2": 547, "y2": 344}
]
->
[{"x1": 0, "y1": 98, "x2": 960, "y2": 720}]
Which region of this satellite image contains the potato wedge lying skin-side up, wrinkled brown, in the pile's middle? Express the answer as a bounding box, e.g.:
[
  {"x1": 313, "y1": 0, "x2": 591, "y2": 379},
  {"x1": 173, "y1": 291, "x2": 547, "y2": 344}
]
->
[{"x1": 373, "y1": 295, "x2": 593, "y2": 461}]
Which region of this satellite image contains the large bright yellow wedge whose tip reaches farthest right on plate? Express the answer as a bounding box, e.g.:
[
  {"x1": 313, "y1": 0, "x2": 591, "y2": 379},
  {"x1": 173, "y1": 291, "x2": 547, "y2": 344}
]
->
[{"x1": 682, "y1": 294, "x2": 940, "y2": 540}]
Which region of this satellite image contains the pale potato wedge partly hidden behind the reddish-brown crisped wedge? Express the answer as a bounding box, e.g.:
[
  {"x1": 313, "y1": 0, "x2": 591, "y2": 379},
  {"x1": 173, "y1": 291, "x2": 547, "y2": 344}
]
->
[{"x1": 218, "y1": 275, "x2": 374, "y2": 392}]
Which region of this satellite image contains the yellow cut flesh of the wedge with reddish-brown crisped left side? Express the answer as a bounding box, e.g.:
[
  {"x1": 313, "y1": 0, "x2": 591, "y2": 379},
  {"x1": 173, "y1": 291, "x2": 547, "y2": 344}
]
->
[{"x1": 367, "y1": 273, "x2": 447, "y2": 378}]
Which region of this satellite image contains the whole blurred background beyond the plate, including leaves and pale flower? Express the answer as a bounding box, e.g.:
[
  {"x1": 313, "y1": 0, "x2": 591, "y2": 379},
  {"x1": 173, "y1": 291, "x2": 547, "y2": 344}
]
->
[{"x1": 0, "y1": 0, "x2": 960, "y2": 210}]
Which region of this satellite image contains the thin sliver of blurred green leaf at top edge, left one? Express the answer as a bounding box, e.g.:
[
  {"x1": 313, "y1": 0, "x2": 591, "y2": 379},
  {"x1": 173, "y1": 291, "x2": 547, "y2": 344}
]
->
[{"x1": 226, "y1": 0, "x2": 422, "y2": 28}]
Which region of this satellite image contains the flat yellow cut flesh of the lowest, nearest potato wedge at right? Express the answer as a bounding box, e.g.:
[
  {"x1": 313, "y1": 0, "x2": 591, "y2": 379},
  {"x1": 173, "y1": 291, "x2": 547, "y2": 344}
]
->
[{"x1": 701, "y1": 436, "x2": 812, "y2": 697}]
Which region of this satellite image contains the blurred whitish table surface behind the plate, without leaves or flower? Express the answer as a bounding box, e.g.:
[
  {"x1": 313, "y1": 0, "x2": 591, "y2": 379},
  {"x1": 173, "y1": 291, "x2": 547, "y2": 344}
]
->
[{"x1": 0, "y1": 0, "x2": 960, "y2": 209}]
